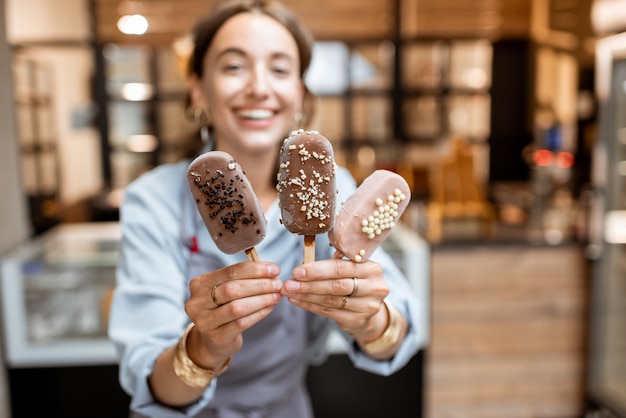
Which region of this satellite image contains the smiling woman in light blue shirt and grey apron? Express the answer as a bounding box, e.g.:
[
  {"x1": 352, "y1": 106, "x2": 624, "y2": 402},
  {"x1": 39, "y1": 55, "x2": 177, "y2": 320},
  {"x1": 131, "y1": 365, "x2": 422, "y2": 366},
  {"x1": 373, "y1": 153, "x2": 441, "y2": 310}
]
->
[{"x1": 109, "y1": 0, "x2": 421, "y2": 418}]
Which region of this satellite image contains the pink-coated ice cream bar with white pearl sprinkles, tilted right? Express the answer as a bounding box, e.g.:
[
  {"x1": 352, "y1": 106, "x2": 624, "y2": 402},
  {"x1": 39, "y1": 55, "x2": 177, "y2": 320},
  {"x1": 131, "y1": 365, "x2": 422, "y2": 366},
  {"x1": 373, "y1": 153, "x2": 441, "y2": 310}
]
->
[{"x1": 328, "y1": 170, "x2": 411, "y2": 262}]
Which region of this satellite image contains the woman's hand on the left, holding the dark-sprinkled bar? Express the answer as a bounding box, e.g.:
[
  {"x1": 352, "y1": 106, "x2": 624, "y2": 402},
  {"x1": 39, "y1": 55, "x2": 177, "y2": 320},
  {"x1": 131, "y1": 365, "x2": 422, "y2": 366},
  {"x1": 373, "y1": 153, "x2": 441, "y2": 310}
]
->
[{"x1": 185, "y1": 261, "x2": 283, "y2": 370}]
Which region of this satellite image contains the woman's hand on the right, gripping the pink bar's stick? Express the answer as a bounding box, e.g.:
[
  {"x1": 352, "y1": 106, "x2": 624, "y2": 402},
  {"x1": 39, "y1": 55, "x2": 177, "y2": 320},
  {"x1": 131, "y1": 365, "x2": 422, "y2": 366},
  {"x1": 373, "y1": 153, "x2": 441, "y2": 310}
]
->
[{"x1": 282, "y1": 259, "x2": 389, "y2": 342}]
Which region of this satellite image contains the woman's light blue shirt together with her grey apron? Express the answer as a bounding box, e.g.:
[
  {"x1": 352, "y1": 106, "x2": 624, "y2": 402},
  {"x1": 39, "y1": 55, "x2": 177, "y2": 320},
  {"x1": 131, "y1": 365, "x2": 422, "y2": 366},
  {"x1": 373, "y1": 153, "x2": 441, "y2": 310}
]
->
[{"x1": 109, "y1": 157, "x2": 422, "y2": 418}]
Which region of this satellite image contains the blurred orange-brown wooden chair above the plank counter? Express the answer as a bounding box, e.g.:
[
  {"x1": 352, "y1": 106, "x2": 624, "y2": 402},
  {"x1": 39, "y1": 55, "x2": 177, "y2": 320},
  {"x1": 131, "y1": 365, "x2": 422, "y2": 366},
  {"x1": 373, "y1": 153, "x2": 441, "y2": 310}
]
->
[{"x1": 426, "y1": 138, "x2": 495, "y2": 243}]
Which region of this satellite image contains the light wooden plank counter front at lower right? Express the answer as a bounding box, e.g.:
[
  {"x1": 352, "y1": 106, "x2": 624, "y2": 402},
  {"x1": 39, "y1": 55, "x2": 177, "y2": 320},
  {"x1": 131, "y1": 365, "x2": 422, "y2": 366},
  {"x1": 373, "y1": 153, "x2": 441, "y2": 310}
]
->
[{"x1": 425, "y1": 246, "x2": 587, "y2": 418}]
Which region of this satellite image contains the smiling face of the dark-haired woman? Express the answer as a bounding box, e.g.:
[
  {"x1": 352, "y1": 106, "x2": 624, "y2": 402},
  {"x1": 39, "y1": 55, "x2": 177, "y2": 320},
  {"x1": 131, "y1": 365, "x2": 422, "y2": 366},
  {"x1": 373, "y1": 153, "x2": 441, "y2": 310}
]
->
[{"x1": 192, "y1": 13, "x2": 304, "y2": 156}]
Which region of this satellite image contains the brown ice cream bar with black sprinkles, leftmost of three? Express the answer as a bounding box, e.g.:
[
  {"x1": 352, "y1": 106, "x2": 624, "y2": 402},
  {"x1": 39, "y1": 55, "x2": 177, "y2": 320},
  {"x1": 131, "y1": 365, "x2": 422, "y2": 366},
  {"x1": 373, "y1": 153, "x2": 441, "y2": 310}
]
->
[{"x1": 187, "y1": 151, "x2": 267, "y2": 261}]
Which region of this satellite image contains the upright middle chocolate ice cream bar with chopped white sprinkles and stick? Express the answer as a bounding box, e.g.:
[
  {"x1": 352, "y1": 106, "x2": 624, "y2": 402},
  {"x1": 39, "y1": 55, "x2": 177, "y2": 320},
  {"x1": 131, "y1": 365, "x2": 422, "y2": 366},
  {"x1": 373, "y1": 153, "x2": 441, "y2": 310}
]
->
[{"x1": 276, "y1": 129, "x2": 337, "y2": 263}]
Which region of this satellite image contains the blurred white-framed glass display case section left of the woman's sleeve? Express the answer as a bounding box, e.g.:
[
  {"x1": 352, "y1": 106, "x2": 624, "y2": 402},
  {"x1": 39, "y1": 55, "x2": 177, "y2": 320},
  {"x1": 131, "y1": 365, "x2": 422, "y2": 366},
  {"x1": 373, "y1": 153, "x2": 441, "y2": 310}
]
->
[{"x1": 0, "y1": 222, "x2": 119, "y2": 368}]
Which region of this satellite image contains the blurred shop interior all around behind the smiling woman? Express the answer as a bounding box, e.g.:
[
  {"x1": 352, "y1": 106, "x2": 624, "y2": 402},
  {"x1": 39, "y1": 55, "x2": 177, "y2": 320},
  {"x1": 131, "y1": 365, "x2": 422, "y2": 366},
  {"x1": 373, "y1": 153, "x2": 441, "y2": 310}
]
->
[{"x1": 0, "y1": 0, "x2": 626, "y2": 418}]
